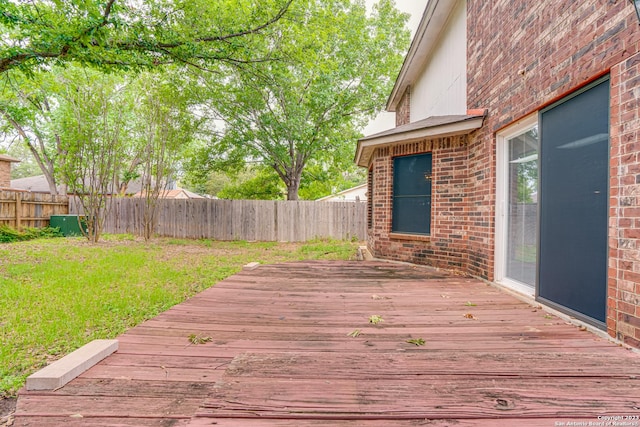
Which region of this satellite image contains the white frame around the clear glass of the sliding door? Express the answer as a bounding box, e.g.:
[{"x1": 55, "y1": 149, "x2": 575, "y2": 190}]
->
[{"x1": 494, "y1": 112, "x2": 538, "y2": 296}]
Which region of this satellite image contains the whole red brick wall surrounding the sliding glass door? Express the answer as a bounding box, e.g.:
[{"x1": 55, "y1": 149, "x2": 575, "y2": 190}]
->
[{"x1": 467, "y1": 0, "x2": 640, "y2": 347}]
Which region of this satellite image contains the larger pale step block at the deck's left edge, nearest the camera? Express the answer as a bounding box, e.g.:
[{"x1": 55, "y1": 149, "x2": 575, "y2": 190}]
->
[{"x1": 27, "y1": 340, "x2": 118, "y2": 390}]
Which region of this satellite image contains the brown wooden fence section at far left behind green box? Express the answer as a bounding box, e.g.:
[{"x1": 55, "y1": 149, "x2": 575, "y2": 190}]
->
[{"x1": 0, "y1": 190, "x2": 69, "y2": 229}]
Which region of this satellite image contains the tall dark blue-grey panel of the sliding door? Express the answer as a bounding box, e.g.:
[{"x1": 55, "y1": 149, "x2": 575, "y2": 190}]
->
[{"x1": 538, "y1": 78, "x2": 609, "y2": 327}]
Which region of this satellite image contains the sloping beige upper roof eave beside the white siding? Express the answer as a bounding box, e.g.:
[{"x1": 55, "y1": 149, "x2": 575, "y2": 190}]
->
[{"x1": 387, "y1": 0, "x2": 458, "y2": 112}]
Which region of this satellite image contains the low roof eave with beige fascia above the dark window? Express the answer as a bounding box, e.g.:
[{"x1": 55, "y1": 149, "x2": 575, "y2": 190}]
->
[{"x1": 355, "y1": 110, "x2": 486, "y2": 167}]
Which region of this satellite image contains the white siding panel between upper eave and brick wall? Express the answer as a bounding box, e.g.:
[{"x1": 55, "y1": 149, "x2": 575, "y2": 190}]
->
[{"x1": 411, "y1": 0, "x2": 467, "y2": 122}]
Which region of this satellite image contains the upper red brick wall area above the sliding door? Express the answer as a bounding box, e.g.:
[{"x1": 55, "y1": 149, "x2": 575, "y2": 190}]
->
[{"x1": 467, "y1": 0, "x2": 640, "y2": 131}]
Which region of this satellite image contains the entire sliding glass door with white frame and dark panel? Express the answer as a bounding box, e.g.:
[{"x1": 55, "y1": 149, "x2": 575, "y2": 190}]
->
[{"x1": 495, "y1": 78, "x2": 610, "y2": 328}]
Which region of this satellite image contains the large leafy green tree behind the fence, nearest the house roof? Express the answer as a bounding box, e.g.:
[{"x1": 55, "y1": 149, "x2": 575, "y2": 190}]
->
[{"x1": 200, "y1": 0, "x2": 409, "y2": 200}]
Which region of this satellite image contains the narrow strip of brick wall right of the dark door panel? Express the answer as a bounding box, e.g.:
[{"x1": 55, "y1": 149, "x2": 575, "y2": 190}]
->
[{"x1": 607, "y1": 52, "x2": 640, "y2": 347}]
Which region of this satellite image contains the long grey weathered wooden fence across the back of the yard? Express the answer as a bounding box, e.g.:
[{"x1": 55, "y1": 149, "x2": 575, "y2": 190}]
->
[{"x1": 70, "y1": 198, "x2": 367, "y2": 242}]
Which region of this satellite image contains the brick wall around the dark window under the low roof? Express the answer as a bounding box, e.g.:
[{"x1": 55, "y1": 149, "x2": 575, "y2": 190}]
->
[{"x1": 368, "y1": 136, "x2": 470, "y2": 271}]
